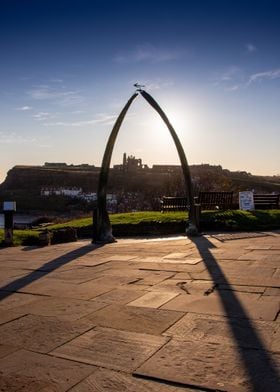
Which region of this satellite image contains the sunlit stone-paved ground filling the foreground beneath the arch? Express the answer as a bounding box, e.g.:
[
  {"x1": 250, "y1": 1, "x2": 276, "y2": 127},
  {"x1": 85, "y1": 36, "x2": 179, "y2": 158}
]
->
[{"x1": 0, "y1": 232, "x2": 280, "y2": 392}]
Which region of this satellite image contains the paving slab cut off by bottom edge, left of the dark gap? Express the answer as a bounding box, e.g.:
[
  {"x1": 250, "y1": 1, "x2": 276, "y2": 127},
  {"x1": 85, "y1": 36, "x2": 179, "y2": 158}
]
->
[{"x1": 70, "y1": 369, "x2": 199, "y2": 392}]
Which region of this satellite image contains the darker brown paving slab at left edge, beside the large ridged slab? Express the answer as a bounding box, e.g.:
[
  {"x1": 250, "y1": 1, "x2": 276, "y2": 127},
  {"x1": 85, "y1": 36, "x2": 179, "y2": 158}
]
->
[{"x1": 0, "y1": 315, "x2": 94, "y2": 353}]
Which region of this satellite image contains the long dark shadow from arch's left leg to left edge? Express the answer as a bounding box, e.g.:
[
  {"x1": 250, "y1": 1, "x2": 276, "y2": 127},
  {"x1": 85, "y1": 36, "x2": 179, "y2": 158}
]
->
[{"x1": 0, "y1": 244, "x2": 102, "y2": 301}]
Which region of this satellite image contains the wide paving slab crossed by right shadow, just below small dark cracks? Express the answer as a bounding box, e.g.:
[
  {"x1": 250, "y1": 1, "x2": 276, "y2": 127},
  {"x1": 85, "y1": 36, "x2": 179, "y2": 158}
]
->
[{"x1": 161, "y1": 290, "x2": 280, "y2": 321}]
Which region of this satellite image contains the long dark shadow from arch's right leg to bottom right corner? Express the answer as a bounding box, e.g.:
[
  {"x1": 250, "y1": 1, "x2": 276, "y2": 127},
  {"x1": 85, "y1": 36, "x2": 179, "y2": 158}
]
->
[{"x1": 192, "y1": 237, "x2": 280, "y2": 392}]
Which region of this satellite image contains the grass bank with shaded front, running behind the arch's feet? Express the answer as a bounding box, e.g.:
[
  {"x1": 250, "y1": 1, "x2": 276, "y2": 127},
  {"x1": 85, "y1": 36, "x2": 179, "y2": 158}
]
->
[{"x1": 0, "y1": 210, "x2": 280, "y2": 245}]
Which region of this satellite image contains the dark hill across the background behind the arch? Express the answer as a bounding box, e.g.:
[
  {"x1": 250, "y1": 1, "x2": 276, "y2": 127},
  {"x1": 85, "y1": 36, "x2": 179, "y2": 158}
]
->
[{"x1": 0, "y1": 164, "x2": 280, "y2": 211}]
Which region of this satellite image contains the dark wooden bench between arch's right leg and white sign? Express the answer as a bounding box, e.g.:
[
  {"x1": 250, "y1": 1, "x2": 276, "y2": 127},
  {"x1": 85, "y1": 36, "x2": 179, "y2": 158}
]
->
[{"x1": 195, "y1": 192, "x2": 233, "y2": 210}]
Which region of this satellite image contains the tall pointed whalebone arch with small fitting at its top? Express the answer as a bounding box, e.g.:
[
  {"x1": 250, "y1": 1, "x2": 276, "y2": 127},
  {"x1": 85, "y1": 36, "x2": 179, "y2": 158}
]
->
[{"x1": 92, "y1": 86, "x2": 198, "y2": 243}]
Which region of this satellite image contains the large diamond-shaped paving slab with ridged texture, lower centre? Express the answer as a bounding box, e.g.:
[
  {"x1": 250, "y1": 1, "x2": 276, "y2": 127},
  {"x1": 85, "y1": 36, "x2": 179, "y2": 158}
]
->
[{"x1": 51, "y1": 327, "x2": 168, "y2": 372}]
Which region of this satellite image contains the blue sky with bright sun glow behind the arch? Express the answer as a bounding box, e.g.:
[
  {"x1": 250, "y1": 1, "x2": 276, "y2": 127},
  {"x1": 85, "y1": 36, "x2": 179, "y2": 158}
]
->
[{"x1": 0, "y1": 0, "x2": 280, "y2": 181}]
